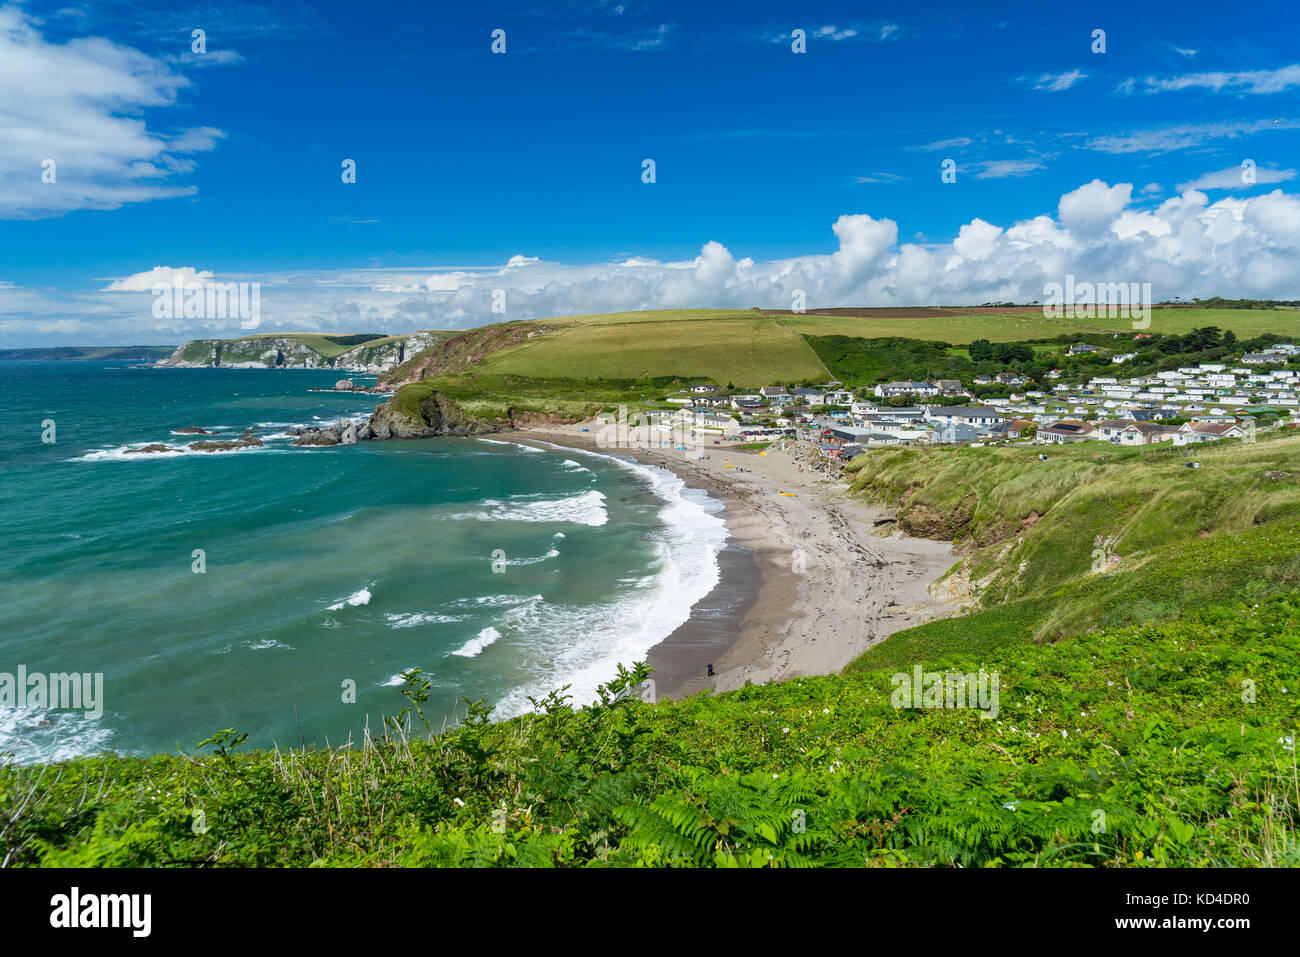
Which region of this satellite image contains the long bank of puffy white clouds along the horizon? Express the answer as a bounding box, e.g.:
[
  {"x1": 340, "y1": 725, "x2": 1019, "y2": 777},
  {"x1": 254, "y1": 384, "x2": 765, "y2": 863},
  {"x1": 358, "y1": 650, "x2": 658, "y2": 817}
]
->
[{"x1": 0, "y1": 179, "x2": 1300, "y2": 346}]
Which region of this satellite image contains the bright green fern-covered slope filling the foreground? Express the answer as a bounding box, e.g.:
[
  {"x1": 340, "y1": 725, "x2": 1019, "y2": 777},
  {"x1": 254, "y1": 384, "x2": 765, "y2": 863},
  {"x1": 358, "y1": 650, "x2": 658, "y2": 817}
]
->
[{"x1": 0, "y1": 597, "x2": 1300, "y2": 867}]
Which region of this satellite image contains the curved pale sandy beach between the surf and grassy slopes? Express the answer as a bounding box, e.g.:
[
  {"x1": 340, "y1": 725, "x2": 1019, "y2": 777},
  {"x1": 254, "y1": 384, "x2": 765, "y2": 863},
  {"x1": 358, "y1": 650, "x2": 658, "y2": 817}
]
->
[{"x1": 504, "y1": 420, "x2": 957, "y2": 698}]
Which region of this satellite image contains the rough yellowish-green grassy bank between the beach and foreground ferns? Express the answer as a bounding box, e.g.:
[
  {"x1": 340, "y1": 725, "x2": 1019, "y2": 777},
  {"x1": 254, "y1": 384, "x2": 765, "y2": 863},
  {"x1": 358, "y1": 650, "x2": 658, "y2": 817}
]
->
[{"x1": 849, "y1": 430, "x2": 1300, "y2": 667}]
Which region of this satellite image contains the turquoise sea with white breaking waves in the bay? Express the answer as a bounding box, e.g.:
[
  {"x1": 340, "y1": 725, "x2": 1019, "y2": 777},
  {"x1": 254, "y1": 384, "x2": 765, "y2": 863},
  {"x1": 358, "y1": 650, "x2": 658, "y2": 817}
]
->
[{"x1": 0, "y1": 361, "x2": 725, "y2": 761}]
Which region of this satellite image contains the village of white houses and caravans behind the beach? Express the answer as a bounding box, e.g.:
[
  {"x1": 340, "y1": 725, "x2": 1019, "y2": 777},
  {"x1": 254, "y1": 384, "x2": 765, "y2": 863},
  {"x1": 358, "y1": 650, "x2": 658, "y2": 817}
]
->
[{"x1": 655, "y1": 342, "x2": 1300, "y2": 462}]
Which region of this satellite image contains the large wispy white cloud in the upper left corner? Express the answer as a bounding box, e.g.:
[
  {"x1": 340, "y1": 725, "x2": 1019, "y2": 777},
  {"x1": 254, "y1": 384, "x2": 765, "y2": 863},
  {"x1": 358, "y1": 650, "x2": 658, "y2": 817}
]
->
[{"x1": 0, "y1": 7, "x2": 222, "y2": 218}]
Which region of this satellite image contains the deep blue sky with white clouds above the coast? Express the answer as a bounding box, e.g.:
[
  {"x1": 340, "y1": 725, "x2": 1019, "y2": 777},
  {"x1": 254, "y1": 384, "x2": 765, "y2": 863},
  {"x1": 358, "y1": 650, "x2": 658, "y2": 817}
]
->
[{"x1": 0, "y1": 0, "x2": 1300, "y2": 347}]
